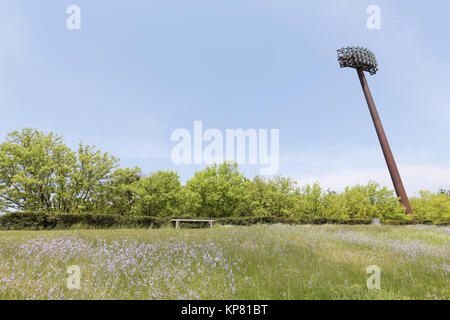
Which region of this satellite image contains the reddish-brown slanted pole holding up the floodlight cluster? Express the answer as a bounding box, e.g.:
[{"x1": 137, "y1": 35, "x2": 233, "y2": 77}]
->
[{"x1": 356, "y1": 68, "x2": 412, "y2": 214}]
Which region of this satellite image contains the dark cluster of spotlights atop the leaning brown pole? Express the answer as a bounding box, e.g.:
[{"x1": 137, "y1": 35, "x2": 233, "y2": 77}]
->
[{"x1": 337, "y1": 47, "x2": 378, "y2": 75}]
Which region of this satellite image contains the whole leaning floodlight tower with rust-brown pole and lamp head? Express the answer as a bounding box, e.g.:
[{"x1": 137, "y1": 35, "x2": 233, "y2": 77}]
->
[{"x1": 337, "y1": 47, "x2": 412, "y2": 214}]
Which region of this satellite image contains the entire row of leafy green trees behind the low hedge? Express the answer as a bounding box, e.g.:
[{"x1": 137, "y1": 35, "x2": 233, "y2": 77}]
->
[{"x1": 0, "y1": 128, "x2": 450, "y2": 219}]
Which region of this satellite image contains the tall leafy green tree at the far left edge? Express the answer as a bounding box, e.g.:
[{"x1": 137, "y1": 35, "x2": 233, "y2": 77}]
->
[{"x1": 0, "y1": 128, "x2": 76, "y2": 211}]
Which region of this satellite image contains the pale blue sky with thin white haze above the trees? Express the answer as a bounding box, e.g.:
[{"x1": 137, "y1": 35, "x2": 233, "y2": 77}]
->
[{"x1": 0, "y1": 0, "x2": 450, "y2": 195}]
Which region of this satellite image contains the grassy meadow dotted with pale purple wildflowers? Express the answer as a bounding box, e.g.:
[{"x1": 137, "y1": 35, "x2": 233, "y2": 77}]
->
[{"x1": 0, "y1": 225, "x2": 450, "y2": 299}]
